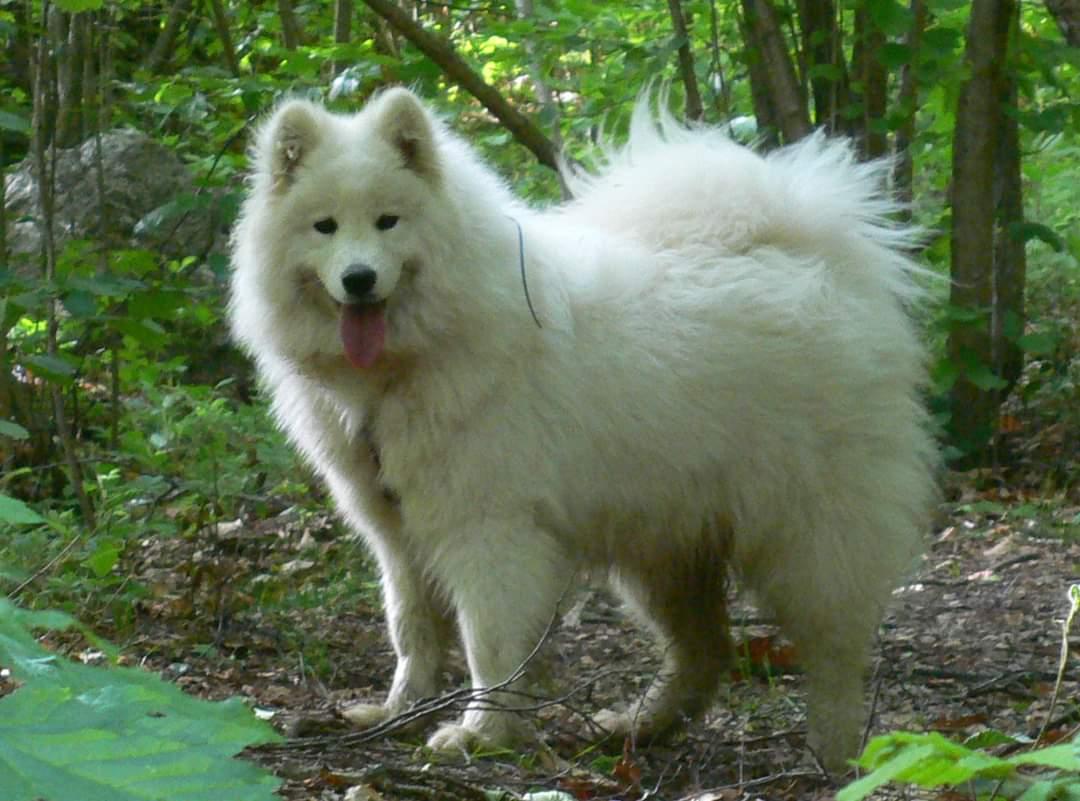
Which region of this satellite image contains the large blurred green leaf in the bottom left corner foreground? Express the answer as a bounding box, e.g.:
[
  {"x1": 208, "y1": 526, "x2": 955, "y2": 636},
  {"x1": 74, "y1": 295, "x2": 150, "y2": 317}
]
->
[{"x1": 0, "y1": 598, "x2": 279, "y2": 801}]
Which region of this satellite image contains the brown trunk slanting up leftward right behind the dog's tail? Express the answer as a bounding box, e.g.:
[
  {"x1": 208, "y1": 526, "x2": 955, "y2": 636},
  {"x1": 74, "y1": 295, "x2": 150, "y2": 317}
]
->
[{"x1": 742, "y1": 0, "x2": 811, "y2": 142}]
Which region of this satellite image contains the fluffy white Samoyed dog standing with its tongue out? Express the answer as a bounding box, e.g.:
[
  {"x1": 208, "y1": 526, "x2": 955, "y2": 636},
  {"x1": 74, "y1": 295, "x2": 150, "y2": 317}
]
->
[{"x1": 230, "y1": 89, "x2": 934, "y2": 768}]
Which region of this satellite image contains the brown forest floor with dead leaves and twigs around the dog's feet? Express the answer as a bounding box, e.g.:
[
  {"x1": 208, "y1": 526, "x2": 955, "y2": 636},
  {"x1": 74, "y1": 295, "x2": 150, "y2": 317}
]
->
[{"x1": 95, "y1": 470, "x2": 1080, "y2": 801}]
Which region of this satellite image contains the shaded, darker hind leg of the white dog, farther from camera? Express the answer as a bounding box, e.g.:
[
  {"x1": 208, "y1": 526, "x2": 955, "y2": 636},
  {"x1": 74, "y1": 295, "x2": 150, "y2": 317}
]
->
[{"x1": 595, "y1": 535, "x2": 733, "y2": 741}]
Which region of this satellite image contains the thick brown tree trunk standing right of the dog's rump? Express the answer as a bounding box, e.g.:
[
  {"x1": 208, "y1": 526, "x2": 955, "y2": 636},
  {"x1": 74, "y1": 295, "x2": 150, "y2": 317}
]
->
[{"x1": 948, "y1": 0, "x2": 1016, "y2": 466}]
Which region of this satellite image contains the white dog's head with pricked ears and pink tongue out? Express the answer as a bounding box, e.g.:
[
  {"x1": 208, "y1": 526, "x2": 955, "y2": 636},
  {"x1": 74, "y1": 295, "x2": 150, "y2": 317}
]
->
[{"x1": 232, "y1": 89, "x2": 447, "y2": 368}]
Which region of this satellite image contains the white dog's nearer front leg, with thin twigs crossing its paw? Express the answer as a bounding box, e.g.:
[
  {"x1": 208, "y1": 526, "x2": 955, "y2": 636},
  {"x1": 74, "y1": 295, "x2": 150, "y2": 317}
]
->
[{"x1": 428, "y1": 520, "x2": 573, "y2": 754}]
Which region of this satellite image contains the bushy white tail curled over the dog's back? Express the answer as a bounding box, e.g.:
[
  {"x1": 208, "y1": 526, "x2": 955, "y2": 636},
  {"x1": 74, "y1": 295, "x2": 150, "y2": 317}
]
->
[{"x1": 567, "y1": 92, "x2": 931, "y2": 302}]
